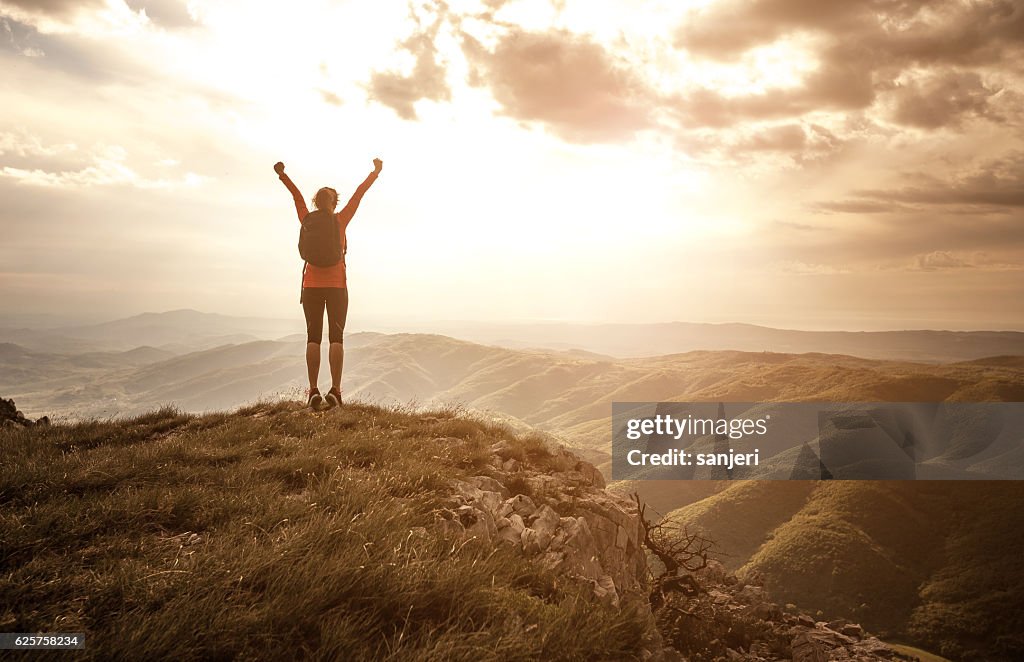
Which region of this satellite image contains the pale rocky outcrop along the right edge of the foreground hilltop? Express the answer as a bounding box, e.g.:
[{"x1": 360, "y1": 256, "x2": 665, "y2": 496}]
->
[{"x1": 435, "y1": 441, "x2": 899, "y2": 662}]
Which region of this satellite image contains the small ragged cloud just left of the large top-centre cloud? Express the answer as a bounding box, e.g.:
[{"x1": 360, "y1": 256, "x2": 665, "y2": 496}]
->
[{"x1": 368, "y1": 4, "x2": 452, "y2": 120}]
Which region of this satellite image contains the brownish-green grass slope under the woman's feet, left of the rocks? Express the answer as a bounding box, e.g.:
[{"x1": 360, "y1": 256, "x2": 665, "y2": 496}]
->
[{"x1": 0, "y1": 403, "x2": 644, "y2": 660}]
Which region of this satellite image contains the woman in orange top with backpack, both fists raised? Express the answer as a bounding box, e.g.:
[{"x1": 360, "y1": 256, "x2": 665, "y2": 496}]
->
[{"x1": 273, "y1": 159, "x2": 384, "y2": 409}]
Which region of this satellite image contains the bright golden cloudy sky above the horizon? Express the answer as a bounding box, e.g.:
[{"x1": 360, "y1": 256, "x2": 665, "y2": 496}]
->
[{"x1": 0, "y1": 0, "x2": 1024, "y2": 330}]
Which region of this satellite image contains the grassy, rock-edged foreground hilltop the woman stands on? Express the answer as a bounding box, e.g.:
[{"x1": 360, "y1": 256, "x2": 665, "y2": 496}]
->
[{"x1": 0, "y1": 402, "x2": 913, "y2": 662}]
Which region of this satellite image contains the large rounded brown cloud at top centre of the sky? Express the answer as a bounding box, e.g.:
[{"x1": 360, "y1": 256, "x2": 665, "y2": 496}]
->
[{"x1": 462, "y1": 28, "x2": 653, "y2": 142}]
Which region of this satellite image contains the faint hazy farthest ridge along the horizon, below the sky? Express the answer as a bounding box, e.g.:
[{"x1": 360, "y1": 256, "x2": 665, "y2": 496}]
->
[{"x1": 0, "y1": 309, "x2": 1024, "y2": 363}]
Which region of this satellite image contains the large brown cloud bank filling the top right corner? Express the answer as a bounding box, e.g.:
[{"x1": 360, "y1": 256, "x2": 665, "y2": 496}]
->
[{"x1": 676, "y1": 0, "x2": 1024, "y2": 129}]
